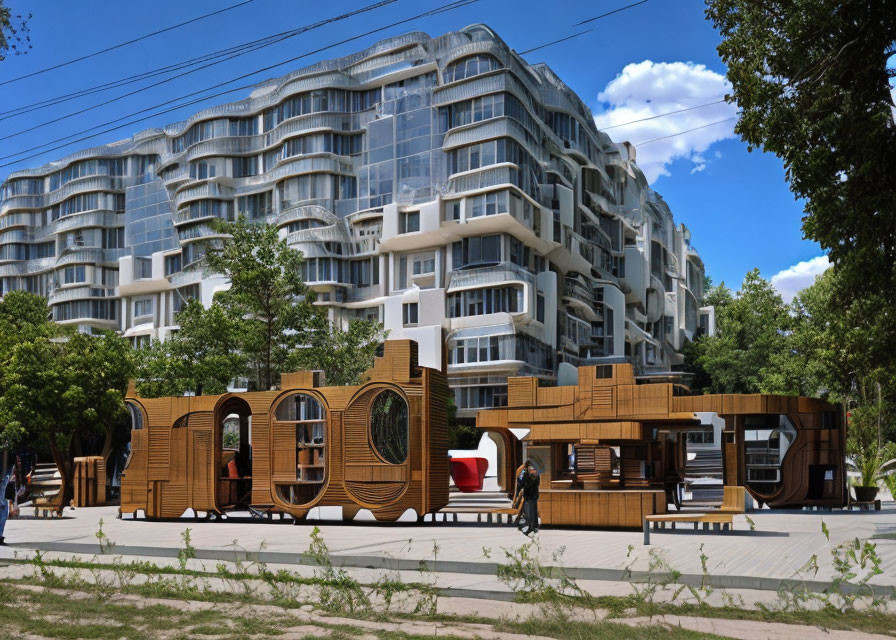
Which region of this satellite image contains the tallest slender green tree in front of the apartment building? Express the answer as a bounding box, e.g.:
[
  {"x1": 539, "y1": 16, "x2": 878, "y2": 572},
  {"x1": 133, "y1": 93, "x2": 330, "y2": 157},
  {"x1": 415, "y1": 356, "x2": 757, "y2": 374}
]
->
[{"x1": 205, "y1": 217, "x2": 318, "y2": 389}]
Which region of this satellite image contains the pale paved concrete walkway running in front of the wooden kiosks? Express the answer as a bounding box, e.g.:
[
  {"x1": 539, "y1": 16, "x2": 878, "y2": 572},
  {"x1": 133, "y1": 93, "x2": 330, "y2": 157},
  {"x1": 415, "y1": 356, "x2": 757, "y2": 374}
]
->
[{"x1": 0, "y1": 502, "x2": 896, "y2": 591}]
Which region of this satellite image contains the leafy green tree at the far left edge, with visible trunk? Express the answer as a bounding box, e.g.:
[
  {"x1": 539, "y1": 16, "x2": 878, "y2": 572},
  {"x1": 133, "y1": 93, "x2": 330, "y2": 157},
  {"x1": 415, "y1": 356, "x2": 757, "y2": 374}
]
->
[{"x1": 0, "y1": 292, "x2": 132, "y2": 500}]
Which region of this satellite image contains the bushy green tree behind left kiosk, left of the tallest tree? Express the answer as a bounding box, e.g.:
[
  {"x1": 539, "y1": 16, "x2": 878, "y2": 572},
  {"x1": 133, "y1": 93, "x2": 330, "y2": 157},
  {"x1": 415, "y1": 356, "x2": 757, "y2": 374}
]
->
[{"x1": 136, "y1": 300, "x2": 246, "y2": 398}]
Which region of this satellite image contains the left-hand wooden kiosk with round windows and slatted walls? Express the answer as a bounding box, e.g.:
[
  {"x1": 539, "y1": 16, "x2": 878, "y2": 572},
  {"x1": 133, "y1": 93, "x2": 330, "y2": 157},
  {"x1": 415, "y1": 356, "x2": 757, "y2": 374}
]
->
[{"x1": 121, "y1": 340, "x2": 449, "y2": 521}]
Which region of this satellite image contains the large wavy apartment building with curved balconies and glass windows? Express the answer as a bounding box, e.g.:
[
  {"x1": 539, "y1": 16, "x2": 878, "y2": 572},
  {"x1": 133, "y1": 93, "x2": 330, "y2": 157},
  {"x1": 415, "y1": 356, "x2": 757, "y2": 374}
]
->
[{"x1": 0, "y1": 25, "x2": 712, "y2": 417}]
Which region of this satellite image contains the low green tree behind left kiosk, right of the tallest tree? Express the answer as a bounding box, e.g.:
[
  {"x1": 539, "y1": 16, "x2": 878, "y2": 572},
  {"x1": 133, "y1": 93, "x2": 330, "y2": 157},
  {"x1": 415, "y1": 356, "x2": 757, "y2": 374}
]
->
[{"x1": 286, "y1": 310, "x2": 386, "y2": 385}]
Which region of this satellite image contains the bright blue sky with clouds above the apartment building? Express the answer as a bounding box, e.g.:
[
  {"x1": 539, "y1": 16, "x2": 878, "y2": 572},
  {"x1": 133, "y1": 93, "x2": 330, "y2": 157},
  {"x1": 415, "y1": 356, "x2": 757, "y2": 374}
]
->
[{"x1": 0, "y1": 0, "x2": 823, "y2": 295}]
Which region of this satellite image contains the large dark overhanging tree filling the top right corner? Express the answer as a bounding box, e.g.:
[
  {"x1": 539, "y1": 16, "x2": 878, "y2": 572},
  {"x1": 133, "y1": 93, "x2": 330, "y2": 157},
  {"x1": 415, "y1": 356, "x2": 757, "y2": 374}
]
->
[{"x1": 706, "y1": 0, "x2": 896, "y2": 384}]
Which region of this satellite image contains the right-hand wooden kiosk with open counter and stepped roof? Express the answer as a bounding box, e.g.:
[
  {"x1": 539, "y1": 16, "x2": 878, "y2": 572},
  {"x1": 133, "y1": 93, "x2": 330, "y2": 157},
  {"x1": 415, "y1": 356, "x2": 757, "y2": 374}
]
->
[{"x1": 476, "y1": 364, "x2": 847, "y2": 528}]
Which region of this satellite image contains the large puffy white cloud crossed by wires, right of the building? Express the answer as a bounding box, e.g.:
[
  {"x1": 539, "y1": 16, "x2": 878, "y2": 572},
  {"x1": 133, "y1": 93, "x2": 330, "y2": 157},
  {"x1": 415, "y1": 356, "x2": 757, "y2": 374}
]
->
[{"x1": 594, "y1": 60, "x2": 737, "y2": 183}]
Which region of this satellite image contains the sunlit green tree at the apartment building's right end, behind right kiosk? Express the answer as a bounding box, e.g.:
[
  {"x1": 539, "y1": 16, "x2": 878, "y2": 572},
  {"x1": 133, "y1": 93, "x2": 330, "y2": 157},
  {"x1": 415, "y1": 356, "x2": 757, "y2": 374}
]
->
[{"x1": 688, "y1": 269, "x2": 787, "y2": 393}]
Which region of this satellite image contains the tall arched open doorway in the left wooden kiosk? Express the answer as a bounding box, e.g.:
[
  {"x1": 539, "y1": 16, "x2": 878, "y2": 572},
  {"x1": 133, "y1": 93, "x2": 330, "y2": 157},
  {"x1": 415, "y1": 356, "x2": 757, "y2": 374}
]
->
[{"x1": 218, "y1": 396, "x2": 252, "y2": 508}]
